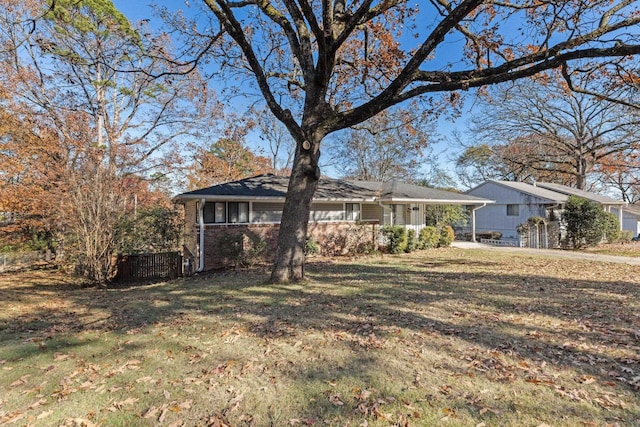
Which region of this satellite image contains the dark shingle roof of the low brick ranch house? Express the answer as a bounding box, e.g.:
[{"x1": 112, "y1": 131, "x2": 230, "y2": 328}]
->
[{"x1": 174, "y1": 174, "x2": 493, "y2": 205}]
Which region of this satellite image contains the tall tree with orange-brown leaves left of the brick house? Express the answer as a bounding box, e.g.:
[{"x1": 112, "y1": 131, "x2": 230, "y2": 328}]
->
[{"x1": 0, "y1": 0, "x2": 205, "y2": 282}]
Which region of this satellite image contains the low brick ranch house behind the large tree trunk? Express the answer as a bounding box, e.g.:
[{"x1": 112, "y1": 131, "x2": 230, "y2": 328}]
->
[{"x1": 174, "y1": 175, "x2": 493, "y2": 270}]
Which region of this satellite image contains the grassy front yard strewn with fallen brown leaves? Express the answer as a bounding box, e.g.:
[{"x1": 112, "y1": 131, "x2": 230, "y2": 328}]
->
[{"x1": 0, "y1": 249, "x2": 640, "y2": 426}]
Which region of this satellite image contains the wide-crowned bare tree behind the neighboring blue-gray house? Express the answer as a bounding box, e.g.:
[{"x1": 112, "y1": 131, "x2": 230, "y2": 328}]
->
[{"x1": 457, "y1": 72, "x2": 640, "y2": 190}]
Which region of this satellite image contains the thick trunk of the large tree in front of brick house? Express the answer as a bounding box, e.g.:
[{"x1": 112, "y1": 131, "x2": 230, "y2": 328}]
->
[{"x1": 270, "y1": 142, "x2": 320, "y2": 283}]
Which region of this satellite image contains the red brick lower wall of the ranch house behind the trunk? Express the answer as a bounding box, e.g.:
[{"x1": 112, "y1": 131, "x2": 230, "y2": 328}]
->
[{"x1": 199, "y1": 222, "x2": 378, "y2": 270}]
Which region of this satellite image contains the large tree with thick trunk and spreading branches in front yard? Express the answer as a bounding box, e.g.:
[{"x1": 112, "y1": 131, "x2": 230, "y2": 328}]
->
[{"x1": 173, "y1": 0, "x2": 640, "y2": 282}]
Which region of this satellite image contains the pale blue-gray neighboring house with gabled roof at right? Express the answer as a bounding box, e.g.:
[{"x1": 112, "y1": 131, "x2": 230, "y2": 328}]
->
[{"x1": 467, "y1": 180, "x2": 640, "y2": 247}]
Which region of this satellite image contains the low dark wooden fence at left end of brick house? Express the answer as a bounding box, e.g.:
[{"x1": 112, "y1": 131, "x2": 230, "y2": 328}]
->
[{"x1": 114, "y1": 252, "x2": 182, "y2": 282}]
